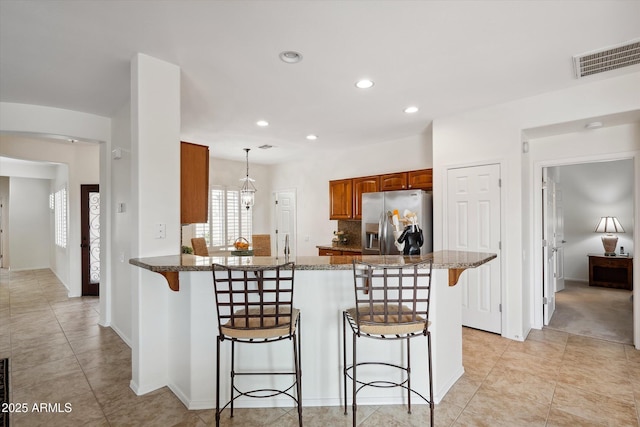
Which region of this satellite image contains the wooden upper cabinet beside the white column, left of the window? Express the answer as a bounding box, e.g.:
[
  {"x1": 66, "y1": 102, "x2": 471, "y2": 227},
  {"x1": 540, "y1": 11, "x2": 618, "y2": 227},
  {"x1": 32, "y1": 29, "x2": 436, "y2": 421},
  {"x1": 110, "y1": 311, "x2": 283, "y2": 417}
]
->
[{"x1": 180, "y1": 142, "x2": 209, "y2": 224}]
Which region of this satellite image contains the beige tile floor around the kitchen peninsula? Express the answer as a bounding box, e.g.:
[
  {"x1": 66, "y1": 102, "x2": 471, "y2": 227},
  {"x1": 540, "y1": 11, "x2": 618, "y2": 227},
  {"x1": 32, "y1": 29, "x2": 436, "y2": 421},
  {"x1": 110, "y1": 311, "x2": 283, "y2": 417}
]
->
[{"x1": 0, "y1": 270, "x2": 640, "y2": 427}]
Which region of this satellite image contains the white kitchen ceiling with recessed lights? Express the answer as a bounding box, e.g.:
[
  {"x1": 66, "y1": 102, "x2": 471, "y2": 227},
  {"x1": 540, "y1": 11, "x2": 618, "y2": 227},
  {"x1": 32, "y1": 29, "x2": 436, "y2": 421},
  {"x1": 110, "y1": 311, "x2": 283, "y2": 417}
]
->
[{"x1": 0, "y1": 0, "x2": 640, "y2": 163}]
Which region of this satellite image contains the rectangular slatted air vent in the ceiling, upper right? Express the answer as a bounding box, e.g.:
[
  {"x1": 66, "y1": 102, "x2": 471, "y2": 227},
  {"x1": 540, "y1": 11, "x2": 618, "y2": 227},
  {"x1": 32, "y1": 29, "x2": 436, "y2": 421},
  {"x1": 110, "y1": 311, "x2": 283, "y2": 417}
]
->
[{"x1": 573, "y1": 39, "x2": 640, "y2": 79}]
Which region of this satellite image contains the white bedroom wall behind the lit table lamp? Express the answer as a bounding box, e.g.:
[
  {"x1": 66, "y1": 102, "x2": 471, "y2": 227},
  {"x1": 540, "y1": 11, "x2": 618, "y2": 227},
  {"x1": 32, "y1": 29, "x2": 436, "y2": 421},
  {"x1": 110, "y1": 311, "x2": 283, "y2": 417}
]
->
[{"x1": 555, "y1": 159, "x2": 634, "y2": 282}]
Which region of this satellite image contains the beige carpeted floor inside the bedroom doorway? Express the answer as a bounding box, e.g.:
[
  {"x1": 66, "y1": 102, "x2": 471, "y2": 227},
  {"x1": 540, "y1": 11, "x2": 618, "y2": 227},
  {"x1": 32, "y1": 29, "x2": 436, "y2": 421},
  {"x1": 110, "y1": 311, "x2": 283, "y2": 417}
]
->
[{"x1": 547, "y1": 280, "x2": 633, "y2": 344}]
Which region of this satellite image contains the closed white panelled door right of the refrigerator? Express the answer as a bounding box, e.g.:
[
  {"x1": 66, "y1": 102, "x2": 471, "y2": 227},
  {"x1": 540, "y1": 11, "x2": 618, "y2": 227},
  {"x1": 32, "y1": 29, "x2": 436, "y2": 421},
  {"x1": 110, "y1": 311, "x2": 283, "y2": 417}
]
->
[{"x1": 447, "y1": 164, "x2": 502, "y2": 333}]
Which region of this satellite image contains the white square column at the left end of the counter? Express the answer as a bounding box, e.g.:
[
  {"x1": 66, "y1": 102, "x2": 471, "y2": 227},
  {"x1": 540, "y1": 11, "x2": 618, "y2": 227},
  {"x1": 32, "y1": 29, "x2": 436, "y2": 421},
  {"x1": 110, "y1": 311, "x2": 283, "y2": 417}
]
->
[{"x1": 130, "y1": 54, "x2": 181, "y2": 394}]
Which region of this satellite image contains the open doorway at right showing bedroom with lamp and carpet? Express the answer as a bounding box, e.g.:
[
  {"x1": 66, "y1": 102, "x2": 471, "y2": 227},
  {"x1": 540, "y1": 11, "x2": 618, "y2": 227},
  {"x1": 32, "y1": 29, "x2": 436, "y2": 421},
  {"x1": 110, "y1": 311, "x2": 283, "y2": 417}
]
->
[{"x1": 541, "y1": 159, "x2": 637, "y2": 344}]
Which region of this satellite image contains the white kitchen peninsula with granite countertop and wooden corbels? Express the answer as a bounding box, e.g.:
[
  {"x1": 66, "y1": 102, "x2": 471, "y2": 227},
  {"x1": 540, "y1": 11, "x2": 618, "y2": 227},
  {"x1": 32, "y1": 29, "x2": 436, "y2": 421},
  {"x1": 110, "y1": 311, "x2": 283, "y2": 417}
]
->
[{"x1": 129, "y1": 251, "x2": 496, "y2": 409}]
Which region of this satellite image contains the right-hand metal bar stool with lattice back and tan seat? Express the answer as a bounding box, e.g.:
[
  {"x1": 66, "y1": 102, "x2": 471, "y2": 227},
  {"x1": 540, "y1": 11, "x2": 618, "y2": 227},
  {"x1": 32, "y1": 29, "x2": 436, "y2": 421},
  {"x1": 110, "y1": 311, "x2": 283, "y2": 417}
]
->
[{"x1": 342, "y1": 260, "x2": 435, "y2": 426}]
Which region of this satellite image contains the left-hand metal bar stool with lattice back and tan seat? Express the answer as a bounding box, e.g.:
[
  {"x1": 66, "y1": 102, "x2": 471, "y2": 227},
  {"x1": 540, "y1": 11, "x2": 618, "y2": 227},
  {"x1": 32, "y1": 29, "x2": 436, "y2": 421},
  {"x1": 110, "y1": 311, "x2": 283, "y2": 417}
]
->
[{"x1": 212, "y1": 262, "x2": 302, "y2": 426}]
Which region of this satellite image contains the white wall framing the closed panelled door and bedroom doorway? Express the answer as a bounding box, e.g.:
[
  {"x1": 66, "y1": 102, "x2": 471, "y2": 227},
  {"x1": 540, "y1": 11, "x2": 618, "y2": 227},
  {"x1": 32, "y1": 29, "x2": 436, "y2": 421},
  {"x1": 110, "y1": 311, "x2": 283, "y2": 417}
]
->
[{"x1": 433, "y1": 73, "x2": 640, "y2": 340}]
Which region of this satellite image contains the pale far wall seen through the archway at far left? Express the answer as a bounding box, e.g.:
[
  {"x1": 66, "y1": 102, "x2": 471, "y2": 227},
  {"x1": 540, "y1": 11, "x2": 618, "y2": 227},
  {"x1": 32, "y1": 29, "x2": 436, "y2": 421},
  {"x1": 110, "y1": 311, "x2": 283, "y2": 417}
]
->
[{"x1": 9, "y1": 178, "x2": 52, "y2": 271}]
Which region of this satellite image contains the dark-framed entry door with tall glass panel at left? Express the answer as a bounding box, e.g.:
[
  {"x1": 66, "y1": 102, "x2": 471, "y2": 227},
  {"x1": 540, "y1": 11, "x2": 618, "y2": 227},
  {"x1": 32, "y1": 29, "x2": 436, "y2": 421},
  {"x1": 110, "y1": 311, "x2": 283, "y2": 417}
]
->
[{"x1": 80, "y1": 184, "x2": 100, "y2": 296}]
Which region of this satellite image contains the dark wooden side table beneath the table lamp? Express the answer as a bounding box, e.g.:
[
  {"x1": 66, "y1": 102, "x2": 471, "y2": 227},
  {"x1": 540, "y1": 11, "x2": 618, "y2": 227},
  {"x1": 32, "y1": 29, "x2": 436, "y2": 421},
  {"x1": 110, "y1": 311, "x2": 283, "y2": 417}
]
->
[{"x1": 588, "y1": 254, "x2": 633, "y2": 291}]
